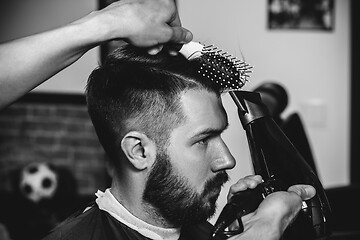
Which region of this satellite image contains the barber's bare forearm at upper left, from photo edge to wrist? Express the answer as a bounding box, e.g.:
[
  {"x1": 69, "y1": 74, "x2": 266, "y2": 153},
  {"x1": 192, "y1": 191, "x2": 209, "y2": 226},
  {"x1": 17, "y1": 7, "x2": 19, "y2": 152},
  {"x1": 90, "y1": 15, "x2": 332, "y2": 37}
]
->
[{"x1": 0, "y1": 15, "x2": 102, "y2": 108}]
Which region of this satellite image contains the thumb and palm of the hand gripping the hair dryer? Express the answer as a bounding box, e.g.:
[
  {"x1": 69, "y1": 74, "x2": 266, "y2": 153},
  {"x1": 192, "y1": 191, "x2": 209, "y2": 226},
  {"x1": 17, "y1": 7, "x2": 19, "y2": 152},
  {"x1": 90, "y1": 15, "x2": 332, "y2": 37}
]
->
[{"x1": 230, "y1": 185, "x2": 316, "y2": 240}]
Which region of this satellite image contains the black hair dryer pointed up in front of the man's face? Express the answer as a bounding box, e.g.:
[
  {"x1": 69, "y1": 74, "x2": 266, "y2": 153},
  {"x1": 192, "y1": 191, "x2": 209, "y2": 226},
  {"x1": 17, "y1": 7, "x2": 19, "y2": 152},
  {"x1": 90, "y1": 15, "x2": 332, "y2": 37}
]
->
[{"x1": 211, "y1": 91, "x2": 331, "y2": 240}]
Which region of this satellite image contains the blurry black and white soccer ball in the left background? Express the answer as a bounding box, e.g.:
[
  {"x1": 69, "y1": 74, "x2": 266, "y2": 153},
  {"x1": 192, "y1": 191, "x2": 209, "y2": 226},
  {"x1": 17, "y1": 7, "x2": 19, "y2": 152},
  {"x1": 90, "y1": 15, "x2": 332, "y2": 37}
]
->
[{"x1": 20, "y1": 162, "x2": 58, "y2": 203}]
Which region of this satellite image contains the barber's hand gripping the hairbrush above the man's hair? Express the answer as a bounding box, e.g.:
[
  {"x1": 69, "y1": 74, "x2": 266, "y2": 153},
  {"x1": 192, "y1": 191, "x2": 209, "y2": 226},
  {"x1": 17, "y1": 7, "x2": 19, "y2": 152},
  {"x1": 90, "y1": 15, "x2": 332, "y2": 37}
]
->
[{"x1": 83, "y1": 0, "x2": 192, "y2": 54}]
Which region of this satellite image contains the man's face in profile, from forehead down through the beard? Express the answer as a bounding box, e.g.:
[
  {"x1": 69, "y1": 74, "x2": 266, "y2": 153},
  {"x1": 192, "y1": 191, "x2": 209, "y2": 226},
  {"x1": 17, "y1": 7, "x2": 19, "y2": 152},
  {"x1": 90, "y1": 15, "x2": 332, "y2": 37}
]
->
[{"x1": 143, "y1": 90, "x2": 235, "y2": 226}]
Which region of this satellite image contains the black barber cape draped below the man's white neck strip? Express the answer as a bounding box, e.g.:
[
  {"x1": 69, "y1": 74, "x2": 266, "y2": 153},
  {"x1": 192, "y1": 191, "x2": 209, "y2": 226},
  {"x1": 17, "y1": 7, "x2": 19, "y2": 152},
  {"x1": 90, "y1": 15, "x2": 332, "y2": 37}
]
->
[{"x1": 43, "y1": 204, "x2": 217, "y2": 240}]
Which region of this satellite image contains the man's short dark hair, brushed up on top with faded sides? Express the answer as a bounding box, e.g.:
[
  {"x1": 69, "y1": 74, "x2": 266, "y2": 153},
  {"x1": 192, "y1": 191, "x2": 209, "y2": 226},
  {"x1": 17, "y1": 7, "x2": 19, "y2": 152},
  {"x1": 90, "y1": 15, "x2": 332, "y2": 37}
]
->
[{"x1": 86, "y1": 45, "x2": 221, "y2": 164}]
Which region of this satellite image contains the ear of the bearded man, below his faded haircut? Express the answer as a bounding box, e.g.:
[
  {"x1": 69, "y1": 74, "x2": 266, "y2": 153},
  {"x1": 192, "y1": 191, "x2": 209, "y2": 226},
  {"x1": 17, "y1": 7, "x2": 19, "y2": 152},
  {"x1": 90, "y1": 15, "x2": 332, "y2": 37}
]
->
[{"x1": 121, "y1": 131, "x2": 156, "y2": 170}]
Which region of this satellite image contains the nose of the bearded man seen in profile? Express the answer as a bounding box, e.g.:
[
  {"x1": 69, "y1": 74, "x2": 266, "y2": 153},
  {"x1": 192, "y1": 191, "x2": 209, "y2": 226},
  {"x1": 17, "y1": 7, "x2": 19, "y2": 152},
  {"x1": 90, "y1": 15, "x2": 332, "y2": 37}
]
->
[{"x1": 211, "y1": 139, "x2": 236, "y2": 172}]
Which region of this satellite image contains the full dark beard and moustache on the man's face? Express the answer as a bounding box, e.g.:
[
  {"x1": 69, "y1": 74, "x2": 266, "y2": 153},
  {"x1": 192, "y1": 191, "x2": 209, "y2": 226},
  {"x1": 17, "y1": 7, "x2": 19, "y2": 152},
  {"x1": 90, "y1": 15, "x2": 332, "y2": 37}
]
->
[{"x1": 143, "y1": 153, "x2": 229, "y2": 227}]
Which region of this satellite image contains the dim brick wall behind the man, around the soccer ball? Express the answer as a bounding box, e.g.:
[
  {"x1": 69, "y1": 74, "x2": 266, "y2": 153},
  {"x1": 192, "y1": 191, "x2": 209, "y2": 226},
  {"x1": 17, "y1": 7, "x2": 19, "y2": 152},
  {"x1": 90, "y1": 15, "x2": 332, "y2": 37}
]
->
[{"x1": 0, "y1": 94, "x2": 109, "y2": 194}]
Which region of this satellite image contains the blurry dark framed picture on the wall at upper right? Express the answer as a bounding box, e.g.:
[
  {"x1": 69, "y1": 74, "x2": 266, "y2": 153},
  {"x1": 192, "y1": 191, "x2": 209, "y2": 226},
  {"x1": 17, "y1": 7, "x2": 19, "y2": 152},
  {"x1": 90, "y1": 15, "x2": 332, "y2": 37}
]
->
[{"x1": 267, "y1": 0, "x2": 335, "y2": 31}]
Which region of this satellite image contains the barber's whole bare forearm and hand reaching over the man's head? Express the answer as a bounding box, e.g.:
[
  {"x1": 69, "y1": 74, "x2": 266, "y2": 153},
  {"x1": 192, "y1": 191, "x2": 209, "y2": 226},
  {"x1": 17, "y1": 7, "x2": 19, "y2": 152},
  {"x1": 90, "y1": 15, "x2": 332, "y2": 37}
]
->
[{"x1": 0, "y1": 0, "x2": 192, "y2": 108}]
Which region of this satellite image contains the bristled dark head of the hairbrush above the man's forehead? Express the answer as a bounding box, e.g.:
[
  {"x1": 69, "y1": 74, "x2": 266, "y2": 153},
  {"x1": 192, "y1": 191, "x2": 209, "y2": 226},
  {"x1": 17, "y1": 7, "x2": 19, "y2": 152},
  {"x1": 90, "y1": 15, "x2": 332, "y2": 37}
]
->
[{"x1": 199, "y1": 45, "x2": 252, "y2": 91}]
